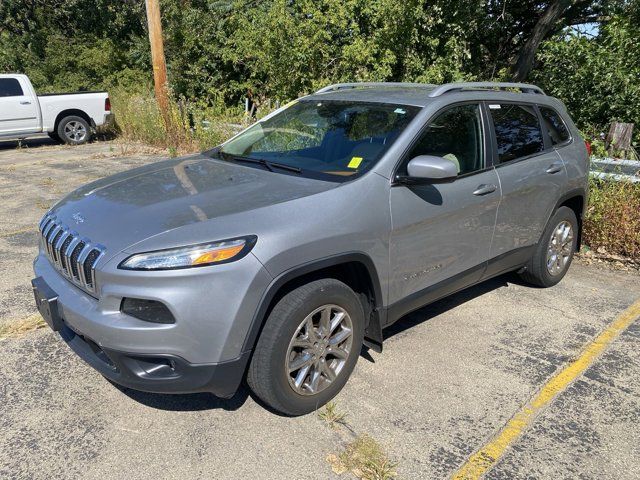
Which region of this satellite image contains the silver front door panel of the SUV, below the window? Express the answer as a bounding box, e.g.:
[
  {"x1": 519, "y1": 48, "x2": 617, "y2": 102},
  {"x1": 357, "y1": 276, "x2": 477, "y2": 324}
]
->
[{"x1": 389, "y1": 168, "x2": 500, "y2": 304}]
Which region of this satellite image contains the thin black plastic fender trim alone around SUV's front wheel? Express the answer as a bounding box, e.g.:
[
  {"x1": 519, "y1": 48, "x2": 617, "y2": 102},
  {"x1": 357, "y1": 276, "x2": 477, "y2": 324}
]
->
[{"x1": 242, "y1": 252, "x2": 386, "y2": 353}]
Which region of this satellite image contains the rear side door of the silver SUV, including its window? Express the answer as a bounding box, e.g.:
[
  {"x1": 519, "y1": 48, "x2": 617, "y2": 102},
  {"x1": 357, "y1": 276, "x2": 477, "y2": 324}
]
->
[{"x1": 487, "y1": 102, "x2": 567, "y2": 266}]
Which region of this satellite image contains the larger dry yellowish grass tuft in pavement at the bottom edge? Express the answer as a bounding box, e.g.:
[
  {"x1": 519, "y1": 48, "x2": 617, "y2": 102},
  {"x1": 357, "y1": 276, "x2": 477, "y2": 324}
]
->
[{"x1": 327, "y1": 435, "x2": 398, "y2": 480}]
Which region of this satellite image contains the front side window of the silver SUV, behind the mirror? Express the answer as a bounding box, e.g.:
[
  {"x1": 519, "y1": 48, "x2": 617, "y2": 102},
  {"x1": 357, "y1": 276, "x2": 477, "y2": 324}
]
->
[{"x1": 407, "y1": 104, "x2": 485, "y2": 175}]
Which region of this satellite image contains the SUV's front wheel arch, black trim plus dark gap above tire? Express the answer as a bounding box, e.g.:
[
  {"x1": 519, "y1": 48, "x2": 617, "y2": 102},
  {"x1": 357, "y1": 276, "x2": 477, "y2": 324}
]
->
[{"x1": 242, "y1": 252, "x2": 384, "y2": 352}]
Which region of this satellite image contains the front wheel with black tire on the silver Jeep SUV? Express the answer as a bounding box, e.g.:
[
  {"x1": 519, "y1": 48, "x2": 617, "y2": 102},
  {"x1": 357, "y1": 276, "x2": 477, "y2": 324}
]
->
[{"x1": 247, "y1": 279, "x2": 364, "y2": 416}]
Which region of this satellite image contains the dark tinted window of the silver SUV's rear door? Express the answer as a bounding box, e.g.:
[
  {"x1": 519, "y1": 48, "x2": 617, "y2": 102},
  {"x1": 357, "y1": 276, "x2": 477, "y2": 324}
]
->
[{"x1": 489, "y1": 103, "x2": 544, "y2": 163}]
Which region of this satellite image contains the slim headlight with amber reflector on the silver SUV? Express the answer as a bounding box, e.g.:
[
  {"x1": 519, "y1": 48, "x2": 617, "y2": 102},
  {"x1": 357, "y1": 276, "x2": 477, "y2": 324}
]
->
[{"x1": 118, "y1": 236, "x2": 257, "y2": 270}]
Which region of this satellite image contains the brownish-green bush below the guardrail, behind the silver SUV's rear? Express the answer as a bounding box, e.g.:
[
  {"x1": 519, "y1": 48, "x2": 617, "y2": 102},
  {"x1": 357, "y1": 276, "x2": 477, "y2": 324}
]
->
[{"x1": 583, "y1": 179, "x2": 640, "y2": 258}]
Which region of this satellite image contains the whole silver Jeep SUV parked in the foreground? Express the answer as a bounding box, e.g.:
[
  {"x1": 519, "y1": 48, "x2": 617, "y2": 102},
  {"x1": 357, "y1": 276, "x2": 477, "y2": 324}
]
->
[{"x1": 33, "y1": 83, "x2": 588, "y2": 415}]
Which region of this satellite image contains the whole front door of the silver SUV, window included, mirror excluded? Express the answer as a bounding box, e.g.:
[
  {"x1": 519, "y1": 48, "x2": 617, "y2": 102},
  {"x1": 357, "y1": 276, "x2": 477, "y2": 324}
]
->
[{"x1": 389, "y1": 103, "x2": 501, "y2": 304}]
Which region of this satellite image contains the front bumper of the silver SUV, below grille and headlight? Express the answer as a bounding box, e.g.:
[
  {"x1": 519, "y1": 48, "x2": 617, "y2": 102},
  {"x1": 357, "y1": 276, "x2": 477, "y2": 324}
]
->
[{"x1": 34, "y1": 248, "x2": 271, "y2": 397}]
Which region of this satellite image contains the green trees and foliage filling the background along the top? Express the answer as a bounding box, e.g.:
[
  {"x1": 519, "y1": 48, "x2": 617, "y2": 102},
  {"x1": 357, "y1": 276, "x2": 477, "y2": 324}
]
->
[{"x1": 0, "y1": 0, "x2": 640, "y2": 148}]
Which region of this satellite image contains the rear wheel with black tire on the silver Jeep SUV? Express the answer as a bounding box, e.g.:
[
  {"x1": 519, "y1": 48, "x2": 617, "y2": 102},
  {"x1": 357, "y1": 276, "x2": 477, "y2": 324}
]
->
[{"x1": 520, "y1": 207, "x2": 579, "y2": 287}]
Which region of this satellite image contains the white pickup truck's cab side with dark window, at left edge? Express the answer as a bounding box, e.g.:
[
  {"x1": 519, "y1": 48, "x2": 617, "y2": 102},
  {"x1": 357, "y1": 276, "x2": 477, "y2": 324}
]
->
[{"x1": 0, "y1": 77, "x2": 40, "y2": 134}]
